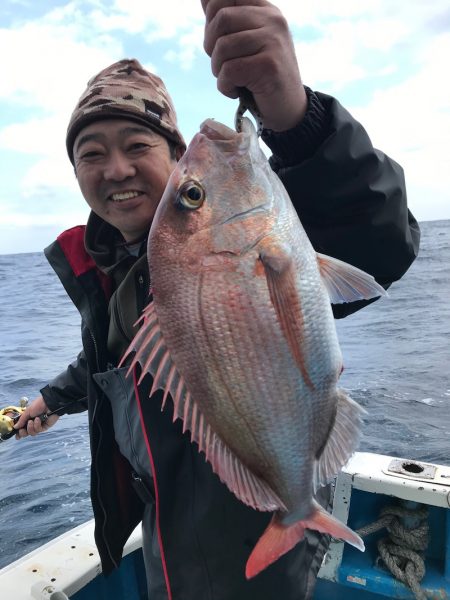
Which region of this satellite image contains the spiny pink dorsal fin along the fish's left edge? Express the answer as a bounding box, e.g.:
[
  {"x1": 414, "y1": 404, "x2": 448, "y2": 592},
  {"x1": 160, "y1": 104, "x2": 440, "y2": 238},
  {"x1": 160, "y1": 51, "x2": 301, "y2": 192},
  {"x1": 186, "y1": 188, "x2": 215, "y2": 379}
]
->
[{"x1": 119, "y1": 303, "x2": 286, "y2": 511}]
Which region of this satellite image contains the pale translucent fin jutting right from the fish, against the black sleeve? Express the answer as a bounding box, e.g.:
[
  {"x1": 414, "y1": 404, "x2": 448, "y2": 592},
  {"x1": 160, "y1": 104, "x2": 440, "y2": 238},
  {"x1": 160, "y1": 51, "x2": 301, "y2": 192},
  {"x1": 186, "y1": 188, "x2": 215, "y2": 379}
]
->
[{"x1": 317, "y1": 253, "x2": 387, "y2": 304}]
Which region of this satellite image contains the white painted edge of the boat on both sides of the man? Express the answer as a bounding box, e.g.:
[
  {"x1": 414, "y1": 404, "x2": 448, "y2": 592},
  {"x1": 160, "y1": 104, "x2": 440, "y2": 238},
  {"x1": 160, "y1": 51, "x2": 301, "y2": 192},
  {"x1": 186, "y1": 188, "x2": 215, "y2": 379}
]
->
[{"x1": 0, "y1": 452, "x2": 450, "y2": 600}]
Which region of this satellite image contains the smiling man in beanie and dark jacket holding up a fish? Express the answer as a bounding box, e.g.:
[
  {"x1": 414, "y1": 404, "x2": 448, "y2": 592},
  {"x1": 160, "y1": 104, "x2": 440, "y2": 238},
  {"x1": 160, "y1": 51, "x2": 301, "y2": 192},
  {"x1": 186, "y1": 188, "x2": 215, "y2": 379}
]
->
[{"x1": 17, "y1": 0, "x2": 419, "y2": 600}]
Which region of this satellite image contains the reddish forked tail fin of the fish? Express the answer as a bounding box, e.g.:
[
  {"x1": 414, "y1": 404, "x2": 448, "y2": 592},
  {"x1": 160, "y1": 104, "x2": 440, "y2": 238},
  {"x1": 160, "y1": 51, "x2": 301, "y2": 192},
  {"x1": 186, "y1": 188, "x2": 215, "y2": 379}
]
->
[{"x1": 245, "y1": 502, "x2": 364, "y2": 579}]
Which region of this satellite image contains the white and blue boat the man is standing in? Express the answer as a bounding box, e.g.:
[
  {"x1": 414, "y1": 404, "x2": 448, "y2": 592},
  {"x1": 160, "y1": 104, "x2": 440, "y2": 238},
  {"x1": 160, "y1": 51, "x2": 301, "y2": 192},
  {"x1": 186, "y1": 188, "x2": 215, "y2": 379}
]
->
[{"x1": 0, "y1": 452, "x2": 450, "y2": 600}]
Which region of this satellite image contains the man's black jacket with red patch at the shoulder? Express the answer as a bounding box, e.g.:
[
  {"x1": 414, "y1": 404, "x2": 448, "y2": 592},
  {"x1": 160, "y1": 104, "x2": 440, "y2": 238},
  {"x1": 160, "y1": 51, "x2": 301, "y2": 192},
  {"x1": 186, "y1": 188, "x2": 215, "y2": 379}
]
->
[{"x1": 42, "y1": 90, "x2": 419, "y2": 600}]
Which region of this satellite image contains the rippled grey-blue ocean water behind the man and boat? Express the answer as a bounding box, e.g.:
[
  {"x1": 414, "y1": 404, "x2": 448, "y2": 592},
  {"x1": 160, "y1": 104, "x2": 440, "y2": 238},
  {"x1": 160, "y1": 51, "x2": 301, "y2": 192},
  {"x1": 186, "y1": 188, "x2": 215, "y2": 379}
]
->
[{"x1": 0, "y1": 221, "x2": 450, "y2": 567}]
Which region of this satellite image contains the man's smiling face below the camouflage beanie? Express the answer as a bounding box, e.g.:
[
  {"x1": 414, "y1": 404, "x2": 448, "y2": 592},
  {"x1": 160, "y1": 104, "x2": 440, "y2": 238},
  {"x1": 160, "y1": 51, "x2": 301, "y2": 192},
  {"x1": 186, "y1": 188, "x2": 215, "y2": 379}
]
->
[{"x1": 74, "y1": 119, "x2": 176, "y2": 242}]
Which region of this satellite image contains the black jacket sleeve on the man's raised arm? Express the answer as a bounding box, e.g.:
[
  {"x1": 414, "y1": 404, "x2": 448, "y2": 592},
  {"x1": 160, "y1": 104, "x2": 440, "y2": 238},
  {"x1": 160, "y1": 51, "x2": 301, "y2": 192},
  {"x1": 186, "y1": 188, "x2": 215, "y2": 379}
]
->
[{"x1": 263, "y1": 88, "x2": 420, "y2": 317}]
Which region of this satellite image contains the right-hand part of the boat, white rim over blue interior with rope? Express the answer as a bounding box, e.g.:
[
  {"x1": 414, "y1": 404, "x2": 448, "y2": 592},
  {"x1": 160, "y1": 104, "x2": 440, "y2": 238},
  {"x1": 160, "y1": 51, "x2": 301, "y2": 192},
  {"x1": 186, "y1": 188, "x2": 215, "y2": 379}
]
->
[{"x1": 315, "y1": 452, "x2": 450, "y2": 600}]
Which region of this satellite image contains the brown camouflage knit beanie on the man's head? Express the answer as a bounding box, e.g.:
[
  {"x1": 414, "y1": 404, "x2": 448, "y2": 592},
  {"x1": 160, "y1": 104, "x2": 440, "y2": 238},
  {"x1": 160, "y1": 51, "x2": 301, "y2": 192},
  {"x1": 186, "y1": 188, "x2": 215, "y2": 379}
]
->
[{"x1": 66, "y1": 59, "x2": 186, "y2": 164}]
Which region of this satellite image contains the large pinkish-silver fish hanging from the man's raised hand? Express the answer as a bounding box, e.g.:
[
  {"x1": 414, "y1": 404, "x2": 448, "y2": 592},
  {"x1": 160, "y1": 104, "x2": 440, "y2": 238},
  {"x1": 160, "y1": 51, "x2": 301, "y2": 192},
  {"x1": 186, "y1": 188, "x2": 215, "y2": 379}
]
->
[{"x1": 121, "y1": 117, "x2": 386, "y2": 578}]
